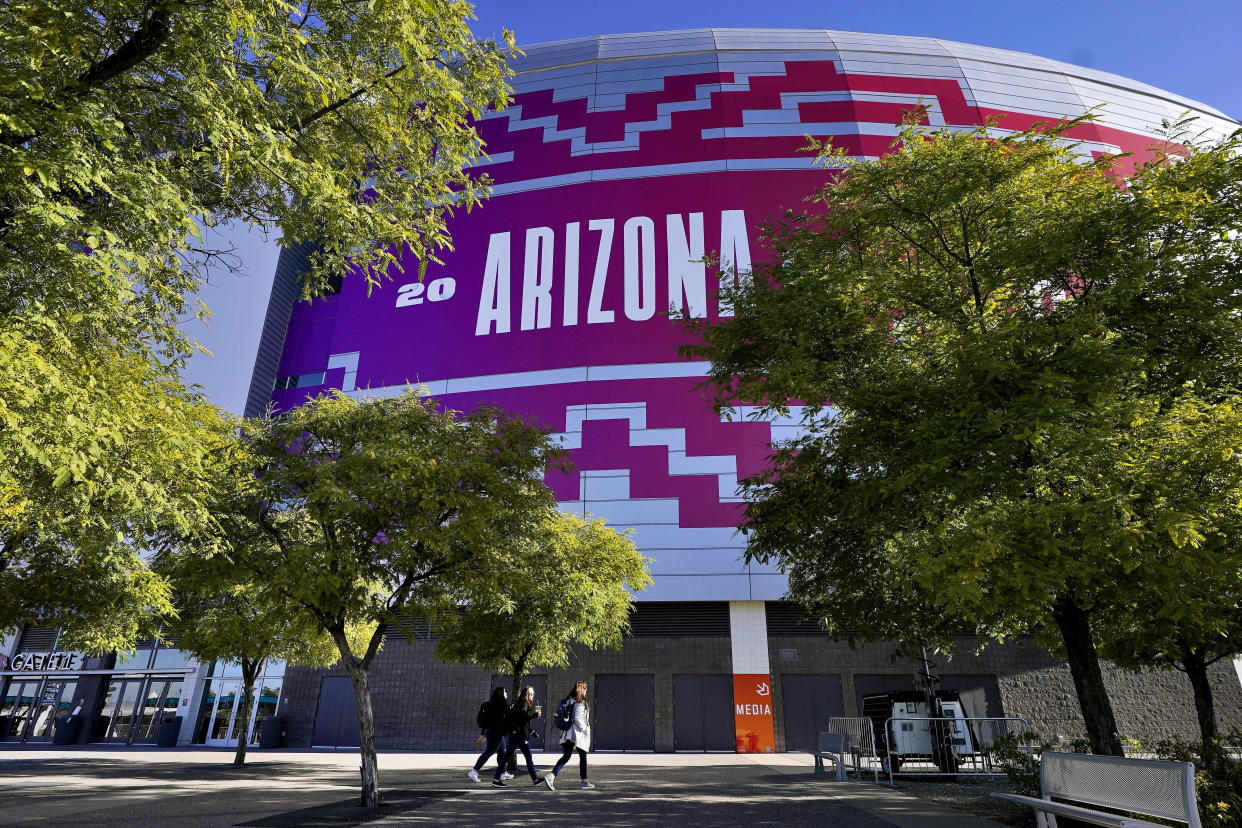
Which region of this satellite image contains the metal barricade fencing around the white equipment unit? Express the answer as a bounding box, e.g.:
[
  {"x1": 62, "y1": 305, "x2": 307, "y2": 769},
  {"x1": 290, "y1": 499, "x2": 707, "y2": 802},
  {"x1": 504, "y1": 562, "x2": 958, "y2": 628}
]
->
[{"x1": 884, "y1": 716, "x2": 1033, "y2": 785}]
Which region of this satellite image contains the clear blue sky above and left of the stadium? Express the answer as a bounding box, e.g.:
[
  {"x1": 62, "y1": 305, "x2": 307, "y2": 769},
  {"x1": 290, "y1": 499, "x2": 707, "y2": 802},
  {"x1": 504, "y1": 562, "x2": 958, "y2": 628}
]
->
[{"x1": 186, "y1": 0, "x2": 1242, "y2": 413}]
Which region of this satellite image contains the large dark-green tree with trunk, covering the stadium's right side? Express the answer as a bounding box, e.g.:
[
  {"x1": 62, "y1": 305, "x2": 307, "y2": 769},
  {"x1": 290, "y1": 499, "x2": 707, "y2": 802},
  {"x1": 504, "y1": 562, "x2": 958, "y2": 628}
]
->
[{"x1": 686, "y1": 116, "x2": 1242, "y2": 754}]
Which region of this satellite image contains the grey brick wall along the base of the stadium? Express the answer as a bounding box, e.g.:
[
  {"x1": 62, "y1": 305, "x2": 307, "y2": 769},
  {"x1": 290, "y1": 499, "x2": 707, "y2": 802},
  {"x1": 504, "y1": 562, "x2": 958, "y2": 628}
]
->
[{"x1": 281, "y1": 637, "x2": 1242, "y2": 751}]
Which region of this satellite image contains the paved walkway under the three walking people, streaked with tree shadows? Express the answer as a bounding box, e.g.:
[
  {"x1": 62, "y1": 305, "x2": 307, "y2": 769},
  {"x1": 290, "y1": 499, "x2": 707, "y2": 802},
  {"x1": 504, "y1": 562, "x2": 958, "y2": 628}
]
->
[{"x1": 0, "y1": 747, "x2": 997, "y2": 828}]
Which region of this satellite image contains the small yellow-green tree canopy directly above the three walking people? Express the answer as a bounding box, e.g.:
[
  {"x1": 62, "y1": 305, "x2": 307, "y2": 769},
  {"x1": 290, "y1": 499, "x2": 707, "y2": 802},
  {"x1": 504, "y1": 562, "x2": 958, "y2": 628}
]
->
[{"x1": 436, "y1": 513, "x2": 651, "y2": 699}]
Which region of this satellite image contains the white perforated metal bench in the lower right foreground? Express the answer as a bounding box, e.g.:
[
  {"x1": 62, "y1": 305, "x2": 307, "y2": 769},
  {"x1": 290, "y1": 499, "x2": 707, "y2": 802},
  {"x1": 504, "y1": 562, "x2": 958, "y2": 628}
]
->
[{"x1": 992, "y1": 751, "x2": 1201, "y2": 828}]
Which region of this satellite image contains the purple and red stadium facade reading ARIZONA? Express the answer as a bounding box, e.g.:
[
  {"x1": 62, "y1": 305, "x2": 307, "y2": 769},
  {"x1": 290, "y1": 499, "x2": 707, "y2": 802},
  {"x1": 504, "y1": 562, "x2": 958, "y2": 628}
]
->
[{"x1": 2, "y1": 29, "x2": 1242, "y2": 751}]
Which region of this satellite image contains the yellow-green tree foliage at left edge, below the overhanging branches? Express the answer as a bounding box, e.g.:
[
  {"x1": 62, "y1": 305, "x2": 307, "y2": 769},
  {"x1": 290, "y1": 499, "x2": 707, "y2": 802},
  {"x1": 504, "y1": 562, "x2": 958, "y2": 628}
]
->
[{"x1": 0, "y1": 340, "x2": 229, "y2": 652}]
